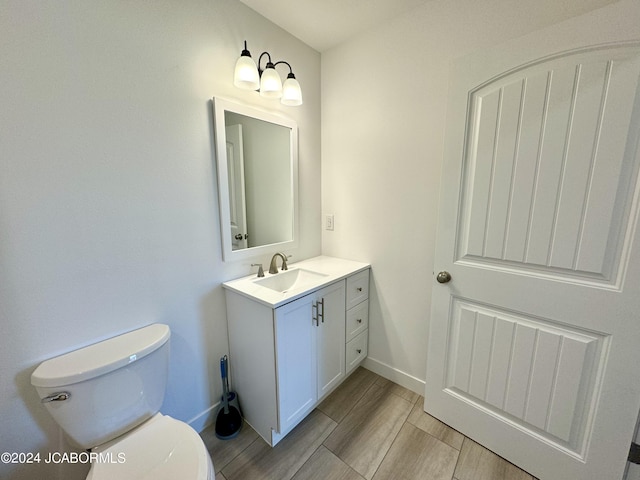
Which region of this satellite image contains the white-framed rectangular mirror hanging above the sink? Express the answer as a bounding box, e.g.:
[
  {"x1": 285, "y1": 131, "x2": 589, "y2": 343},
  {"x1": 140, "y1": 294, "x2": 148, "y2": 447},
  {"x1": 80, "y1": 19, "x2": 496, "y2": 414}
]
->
[{"x1": 213, "y1": 98, "x2": 298, "y2": 261}]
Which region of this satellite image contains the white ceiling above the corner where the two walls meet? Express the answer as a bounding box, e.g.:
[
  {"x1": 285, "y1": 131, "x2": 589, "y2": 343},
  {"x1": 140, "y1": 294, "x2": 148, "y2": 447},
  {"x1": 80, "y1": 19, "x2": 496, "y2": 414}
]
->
[{"x1": 240, "y1": 0, "x2": 430, "y2": 52}]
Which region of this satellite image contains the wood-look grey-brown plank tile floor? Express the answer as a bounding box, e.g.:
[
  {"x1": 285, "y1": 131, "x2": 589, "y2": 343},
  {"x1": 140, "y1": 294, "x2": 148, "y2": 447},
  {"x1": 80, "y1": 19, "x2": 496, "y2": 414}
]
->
[{"x1": 201, "y1": 368, "x2": 536, "y2": 480}]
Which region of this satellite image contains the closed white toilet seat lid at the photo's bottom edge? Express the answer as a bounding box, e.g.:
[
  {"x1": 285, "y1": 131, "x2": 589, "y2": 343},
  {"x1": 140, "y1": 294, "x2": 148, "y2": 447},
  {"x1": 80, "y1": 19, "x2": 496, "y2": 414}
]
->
[{"x1": 87, "y1": 413, "x2": 215, "y2": 480}]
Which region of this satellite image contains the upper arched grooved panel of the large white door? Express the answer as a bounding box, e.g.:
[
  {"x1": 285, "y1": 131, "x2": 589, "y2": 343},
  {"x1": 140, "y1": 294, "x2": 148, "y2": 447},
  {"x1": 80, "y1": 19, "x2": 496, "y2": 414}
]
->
[{"x1": 458, "y1": 47, "x2": 639, "y2": 283}]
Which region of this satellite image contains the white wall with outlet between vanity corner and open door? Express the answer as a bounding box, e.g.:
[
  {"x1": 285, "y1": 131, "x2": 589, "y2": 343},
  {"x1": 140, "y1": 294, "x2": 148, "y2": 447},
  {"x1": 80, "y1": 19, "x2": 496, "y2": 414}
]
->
[{"x1": 322, "y1": 0, "x2": 640, "y2": 392}]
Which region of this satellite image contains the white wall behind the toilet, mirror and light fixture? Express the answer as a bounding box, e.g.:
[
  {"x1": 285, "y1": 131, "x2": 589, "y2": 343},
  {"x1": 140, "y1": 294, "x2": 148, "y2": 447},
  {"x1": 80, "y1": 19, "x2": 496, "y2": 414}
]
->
[{"x1": 0, "y1": 0, "x2": 321, "y2": 480}]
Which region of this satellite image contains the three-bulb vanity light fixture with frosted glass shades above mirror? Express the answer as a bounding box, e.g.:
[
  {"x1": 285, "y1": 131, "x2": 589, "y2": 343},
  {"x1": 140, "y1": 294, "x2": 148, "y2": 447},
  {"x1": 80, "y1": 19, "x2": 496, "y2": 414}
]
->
[{"x1": 233, "y1": 40, "x2": 302, "y2": 106}]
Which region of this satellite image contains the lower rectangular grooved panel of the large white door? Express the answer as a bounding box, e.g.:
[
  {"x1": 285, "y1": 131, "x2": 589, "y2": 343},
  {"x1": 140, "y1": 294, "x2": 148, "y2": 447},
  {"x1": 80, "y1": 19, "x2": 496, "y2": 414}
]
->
[{"x1": 445, "y1": 298, "x2": 608, "y2": 456}]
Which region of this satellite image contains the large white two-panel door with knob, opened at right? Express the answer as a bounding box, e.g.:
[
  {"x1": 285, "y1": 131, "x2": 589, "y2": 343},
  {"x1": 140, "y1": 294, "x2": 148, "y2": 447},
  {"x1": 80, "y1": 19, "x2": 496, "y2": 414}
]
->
[{"x1": 425, "y1": 44, "x2": 640, "y2": 480}]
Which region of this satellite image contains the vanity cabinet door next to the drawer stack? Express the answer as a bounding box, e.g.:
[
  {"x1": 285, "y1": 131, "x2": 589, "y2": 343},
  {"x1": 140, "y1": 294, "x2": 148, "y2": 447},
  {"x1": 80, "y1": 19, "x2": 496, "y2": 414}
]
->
[{"x1": 314, "y1": 281, "x2": 345, "y2": 399}]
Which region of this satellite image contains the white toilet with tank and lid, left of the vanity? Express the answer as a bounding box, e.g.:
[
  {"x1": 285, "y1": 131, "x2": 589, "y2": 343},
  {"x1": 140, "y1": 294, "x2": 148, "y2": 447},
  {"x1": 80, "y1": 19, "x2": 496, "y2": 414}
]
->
[{"x1": 31, "y1": 324, "x2": 215, "y2": 480}]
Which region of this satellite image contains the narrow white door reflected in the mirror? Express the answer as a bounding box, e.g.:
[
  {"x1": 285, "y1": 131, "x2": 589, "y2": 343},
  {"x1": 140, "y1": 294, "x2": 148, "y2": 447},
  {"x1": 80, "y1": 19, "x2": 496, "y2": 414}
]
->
[{"x1": 225, "y1": 125, "x2": 249, "y2": 250}]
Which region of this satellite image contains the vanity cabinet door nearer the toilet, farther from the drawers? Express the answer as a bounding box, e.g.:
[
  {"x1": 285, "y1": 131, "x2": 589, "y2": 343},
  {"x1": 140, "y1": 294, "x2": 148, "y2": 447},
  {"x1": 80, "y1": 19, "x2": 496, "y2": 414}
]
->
[{"x1": 275, "y1": 294, "x2": 317, "y2": 432}]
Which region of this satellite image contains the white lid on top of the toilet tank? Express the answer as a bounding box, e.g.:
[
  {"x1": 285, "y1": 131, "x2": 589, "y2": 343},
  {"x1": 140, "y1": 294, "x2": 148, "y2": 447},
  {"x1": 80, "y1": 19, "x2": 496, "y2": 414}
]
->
[{"x1": 31, "y1": 323, "x2": 171, "y2": 387}]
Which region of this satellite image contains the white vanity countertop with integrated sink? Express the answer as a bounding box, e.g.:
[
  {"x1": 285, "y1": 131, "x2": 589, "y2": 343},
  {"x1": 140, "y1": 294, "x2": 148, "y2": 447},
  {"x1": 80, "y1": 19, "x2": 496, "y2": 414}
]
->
[{"x1": 222, "y1": 255, "x2": 370, "y2": 308}]
